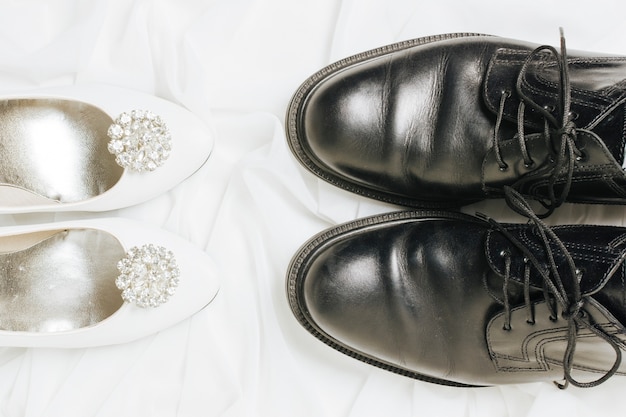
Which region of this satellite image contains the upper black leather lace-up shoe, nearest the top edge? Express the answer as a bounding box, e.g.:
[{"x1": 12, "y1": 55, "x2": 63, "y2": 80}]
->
[{"x1": 286, "y1": 34, "x2": 626, "y2": 214}]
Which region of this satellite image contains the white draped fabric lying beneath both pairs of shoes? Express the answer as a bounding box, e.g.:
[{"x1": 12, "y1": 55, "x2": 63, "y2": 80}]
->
[{"x1": 0, "y1": 0, "x2": 626, "y2": 417}]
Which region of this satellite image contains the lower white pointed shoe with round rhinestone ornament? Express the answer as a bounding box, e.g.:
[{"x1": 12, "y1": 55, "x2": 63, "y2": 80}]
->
[{"x1": 0, "y1": 218, "x2": 219, "y2": 348}]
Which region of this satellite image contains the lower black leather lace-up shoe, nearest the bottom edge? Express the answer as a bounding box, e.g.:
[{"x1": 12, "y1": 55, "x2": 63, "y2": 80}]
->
[{"x1": 287, "y1": 202, "x2": 626, "y2": 387}]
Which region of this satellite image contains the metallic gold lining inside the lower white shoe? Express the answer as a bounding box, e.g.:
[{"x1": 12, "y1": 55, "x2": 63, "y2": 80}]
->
[{"x1": 0, "y1": 229, "x2": 125, "y2": 333}]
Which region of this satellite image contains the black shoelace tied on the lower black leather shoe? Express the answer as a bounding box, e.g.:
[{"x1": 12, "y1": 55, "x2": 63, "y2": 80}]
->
[{"x1": 479, "y1": 186, "x2": 624, "y2": 389}]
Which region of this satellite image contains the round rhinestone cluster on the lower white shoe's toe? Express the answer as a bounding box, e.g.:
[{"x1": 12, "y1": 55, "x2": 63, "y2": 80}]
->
[{"x1": 115, "y1": 244, "x2": 180, "y2": 307}]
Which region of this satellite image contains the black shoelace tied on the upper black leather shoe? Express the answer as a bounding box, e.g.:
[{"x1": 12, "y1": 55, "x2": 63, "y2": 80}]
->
[{"x1": 493, "y1": 29, "x2": 583, "y2": 218}]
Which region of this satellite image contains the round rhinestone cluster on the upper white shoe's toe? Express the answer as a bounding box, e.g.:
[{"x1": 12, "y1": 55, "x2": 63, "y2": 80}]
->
[{"x1": 107, "y1": 110, "x2": 172, "y2": 172}]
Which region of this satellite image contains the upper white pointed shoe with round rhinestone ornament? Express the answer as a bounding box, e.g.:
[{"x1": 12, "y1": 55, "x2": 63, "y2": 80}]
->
[{"x1": 0, "y1": 85, "x2": 213, "y2": 213}]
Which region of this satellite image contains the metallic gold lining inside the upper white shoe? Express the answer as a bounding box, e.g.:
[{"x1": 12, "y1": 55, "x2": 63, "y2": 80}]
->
[{"x1": 0, "y1": 99, "x2": 123, "y2": 206}]
